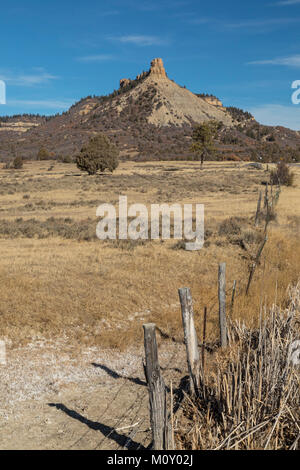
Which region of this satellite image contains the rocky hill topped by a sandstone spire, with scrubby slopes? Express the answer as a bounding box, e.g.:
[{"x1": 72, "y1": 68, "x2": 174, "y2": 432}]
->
[{"x1": 0, "y1": 59, "x2": 300, "y2": 161}]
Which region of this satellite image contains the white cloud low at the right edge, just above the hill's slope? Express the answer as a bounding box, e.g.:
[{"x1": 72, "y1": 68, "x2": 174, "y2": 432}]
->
[{"x1": 248, "y1": 104, "x2": 300, "y2": 131}]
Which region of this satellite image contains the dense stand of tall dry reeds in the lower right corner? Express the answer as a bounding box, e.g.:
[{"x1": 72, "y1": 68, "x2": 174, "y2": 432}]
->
[{"x1": 177, "y1": 285, "x2": 300, "y2": 450}]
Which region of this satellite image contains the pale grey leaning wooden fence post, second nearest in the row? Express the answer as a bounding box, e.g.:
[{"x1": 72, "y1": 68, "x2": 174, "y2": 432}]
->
[{"x1": 178, "y1": 287, "x2": 200, "y2": 394}]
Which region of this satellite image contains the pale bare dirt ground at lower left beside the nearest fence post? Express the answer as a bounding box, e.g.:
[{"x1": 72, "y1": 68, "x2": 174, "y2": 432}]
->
[{"x1": 0, "y1": 342, "x2": 186, "y2": 450}]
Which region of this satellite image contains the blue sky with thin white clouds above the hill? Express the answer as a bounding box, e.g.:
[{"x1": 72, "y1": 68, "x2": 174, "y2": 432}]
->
[{"x1": 0, "y1": 0, "x2": 300, "y2": 130}]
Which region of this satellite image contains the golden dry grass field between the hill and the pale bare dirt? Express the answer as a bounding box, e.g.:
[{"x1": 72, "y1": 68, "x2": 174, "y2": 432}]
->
[{"x1": 0, "y1": 162, "x2": 300, "y2": 349}]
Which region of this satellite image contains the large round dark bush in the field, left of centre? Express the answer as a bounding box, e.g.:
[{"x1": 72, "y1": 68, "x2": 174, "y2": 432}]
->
[{"x1": 75, "y1": 134, "x2": 119, "y2": 175}]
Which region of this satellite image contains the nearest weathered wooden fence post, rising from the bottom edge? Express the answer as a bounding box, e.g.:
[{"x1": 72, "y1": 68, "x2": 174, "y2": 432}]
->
[{"x1": 143, "y1": 323, "x2": 170, "y2": 450}]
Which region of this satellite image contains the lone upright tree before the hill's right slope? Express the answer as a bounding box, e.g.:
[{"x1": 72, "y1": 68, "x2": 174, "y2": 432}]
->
[{"x1": 191, "y1": 120, "x2": 223, "y2": 168}]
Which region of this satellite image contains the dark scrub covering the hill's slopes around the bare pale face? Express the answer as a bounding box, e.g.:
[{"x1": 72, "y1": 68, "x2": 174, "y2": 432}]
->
[{"x1": 0, "y1": 59, "x2": 300, "y2": 162}]
